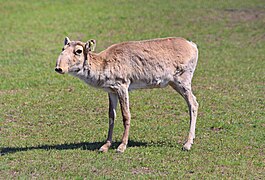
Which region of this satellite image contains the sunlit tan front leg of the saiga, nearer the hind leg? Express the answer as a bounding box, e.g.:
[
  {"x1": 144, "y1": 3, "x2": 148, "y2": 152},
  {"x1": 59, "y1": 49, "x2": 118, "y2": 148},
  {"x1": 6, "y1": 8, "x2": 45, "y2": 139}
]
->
[{"x1": 117, "y1": 86, "x2": 131, "y2": 153}]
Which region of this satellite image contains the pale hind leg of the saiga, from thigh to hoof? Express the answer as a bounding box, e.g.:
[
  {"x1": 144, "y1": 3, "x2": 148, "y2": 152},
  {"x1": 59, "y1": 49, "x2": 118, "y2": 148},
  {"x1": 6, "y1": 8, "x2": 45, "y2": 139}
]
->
[{"x1": 170, "y1": 72, "x2": 199, "y2": 150}]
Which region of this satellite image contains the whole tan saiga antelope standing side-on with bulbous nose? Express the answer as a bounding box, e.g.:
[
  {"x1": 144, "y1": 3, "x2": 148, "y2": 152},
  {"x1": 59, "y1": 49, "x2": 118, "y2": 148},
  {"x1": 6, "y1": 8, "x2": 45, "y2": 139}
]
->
[{"x1": 56, "y1": 38, "x2": 198, "y2": 152}]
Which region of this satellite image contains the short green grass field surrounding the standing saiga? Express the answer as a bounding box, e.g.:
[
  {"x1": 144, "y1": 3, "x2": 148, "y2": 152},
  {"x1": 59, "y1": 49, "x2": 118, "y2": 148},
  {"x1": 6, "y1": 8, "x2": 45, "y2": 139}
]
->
[{"x1": 0, "y1": 0, "x2": 265, "y2": 179}]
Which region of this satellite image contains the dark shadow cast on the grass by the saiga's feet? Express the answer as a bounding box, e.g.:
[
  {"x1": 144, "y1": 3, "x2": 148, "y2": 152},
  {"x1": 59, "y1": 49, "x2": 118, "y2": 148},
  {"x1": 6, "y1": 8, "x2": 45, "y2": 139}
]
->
[{"x1": 0, "y1": 141, "x2": 147, "y2": 156}]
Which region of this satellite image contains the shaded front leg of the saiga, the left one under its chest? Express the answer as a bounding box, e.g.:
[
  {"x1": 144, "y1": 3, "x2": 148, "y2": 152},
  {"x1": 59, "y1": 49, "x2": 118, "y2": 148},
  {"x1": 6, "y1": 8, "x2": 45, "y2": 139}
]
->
[{"x1": 99, "y1": 93, "x2": 118, "y2": 152}]
